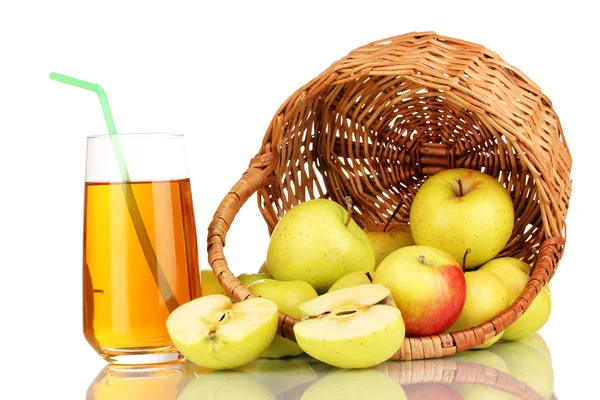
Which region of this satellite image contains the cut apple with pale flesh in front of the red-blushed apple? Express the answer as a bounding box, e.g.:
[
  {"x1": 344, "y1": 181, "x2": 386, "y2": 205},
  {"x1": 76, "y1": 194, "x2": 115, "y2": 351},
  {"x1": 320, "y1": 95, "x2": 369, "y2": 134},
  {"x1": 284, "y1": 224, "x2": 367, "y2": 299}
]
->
[{"x1": 294, "y1": 284, "x2": 405, "y2": 368}]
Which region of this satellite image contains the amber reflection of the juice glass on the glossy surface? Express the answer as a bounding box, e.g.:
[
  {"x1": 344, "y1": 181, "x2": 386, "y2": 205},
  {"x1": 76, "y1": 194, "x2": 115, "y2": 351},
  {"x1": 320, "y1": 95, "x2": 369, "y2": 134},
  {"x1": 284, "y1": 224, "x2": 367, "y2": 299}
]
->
[{"x1": 86, "y1": 361, "x2": 194, "y2": 400}]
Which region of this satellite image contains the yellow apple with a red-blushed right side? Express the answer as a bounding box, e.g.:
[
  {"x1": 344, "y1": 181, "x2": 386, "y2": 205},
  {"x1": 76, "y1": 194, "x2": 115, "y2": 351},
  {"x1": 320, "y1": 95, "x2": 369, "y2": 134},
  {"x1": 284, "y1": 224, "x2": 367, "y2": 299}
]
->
[{"x1": 373, "y1": 246, "x2": 466, "y2": 336}]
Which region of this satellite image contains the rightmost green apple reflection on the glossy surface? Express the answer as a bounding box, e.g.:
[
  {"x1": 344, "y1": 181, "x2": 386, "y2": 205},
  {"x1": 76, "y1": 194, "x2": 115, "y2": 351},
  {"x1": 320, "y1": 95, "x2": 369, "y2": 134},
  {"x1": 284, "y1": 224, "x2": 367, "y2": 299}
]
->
[{"x1": 490, "y1": 341, "x2": 554, "y2": 399}]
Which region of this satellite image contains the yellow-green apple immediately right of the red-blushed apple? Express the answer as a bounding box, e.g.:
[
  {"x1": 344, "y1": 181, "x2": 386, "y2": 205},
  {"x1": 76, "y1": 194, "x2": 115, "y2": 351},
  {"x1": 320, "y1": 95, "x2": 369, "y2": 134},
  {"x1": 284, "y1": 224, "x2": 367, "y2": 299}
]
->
[{"x1": 448, "y1": 269, "x2": 508, "y2": 349}]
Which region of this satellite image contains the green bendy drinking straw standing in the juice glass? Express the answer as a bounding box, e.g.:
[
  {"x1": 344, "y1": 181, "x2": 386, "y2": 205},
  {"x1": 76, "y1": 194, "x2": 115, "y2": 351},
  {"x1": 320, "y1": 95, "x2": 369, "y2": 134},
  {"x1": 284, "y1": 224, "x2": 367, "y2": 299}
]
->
[{"x1": 50, "y1": 72, "x2": 179, "y2": 311}]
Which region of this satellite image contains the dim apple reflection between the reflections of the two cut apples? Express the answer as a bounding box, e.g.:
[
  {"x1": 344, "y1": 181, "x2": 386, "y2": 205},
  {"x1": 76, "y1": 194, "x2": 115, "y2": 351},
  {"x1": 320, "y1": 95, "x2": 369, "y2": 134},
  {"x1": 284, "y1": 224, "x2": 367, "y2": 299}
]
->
[{"x1": 240, "y1": 358, "x2": 317, "y2": 396}]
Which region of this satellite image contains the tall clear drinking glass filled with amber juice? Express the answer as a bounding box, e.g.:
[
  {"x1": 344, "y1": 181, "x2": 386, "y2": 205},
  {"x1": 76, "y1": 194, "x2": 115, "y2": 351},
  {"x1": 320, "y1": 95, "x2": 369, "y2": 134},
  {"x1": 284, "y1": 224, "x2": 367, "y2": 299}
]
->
[{"x1": 83, "y1": 133, "x2": 201, "y2": 364}]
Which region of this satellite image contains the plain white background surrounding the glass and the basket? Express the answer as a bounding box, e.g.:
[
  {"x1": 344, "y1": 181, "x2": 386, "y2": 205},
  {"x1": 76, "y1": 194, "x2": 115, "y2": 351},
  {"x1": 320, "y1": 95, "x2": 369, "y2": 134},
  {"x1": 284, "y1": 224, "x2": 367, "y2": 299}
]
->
[{"x1": 0, "y1": 0, "x2": 600, "y2": 399}]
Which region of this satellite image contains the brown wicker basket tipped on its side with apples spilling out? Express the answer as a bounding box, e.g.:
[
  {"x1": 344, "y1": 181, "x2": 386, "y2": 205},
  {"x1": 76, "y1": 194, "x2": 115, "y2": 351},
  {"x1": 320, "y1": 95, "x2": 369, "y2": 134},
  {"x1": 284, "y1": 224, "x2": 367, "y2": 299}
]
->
[{"x1": 208, "y1": 33, "x2": 571, "y2": 360}]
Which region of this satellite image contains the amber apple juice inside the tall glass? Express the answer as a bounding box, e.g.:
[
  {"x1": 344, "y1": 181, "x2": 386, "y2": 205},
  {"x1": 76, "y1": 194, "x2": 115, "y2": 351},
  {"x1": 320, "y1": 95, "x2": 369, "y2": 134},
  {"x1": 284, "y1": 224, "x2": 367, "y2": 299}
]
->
[{"x1": 83, "y1": 179, "x2": 201, "y2": 360}]
